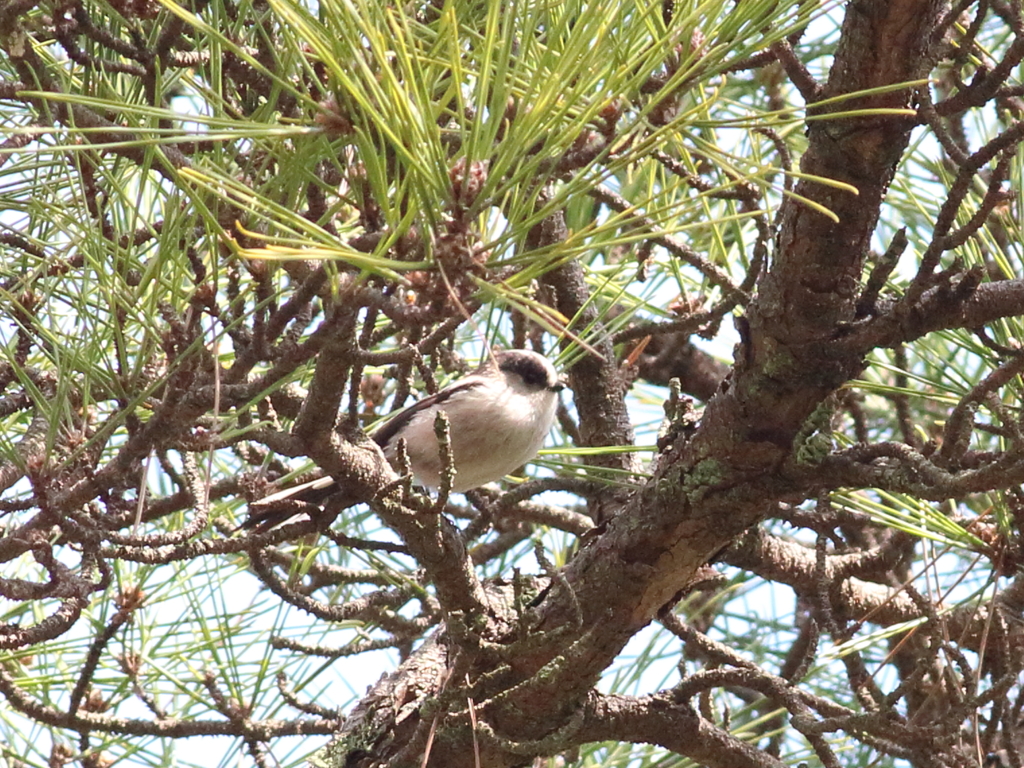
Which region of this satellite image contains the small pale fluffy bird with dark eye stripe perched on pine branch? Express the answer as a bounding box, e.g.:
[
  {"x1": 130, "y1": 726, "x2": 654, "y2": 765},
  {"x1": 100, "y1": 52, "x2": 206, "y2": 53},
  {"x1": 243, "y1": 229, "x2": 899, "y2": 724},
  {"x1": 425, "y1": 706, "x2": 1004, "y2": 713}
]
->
[{"x1": 241, "y1": 349, "x2": 564, "y2": 530}]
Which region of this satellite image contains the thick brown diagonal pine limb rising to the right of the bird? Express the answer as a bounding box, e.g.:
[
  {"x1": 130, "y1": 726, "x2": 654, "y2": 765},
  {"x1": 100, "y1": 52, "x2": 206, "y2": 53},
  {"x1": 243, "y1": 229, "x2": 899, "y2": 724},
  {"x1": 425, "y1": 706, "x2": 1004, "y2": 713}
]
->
[{"x1": 473, "y1": 0, "x2": 958, "y2": 757}]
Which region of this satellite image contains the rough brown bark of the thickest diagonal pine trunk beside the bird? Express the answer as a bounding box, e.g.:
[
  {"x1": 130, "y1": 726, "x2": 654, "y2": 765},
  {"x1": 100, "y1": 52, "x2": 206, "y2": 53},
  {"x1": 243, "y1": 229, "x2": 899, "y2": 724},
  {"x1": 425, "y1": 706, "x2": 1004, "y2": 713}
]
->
[{"x1": 323, "y1": 0, "x2": 962, "y2": 768}]
